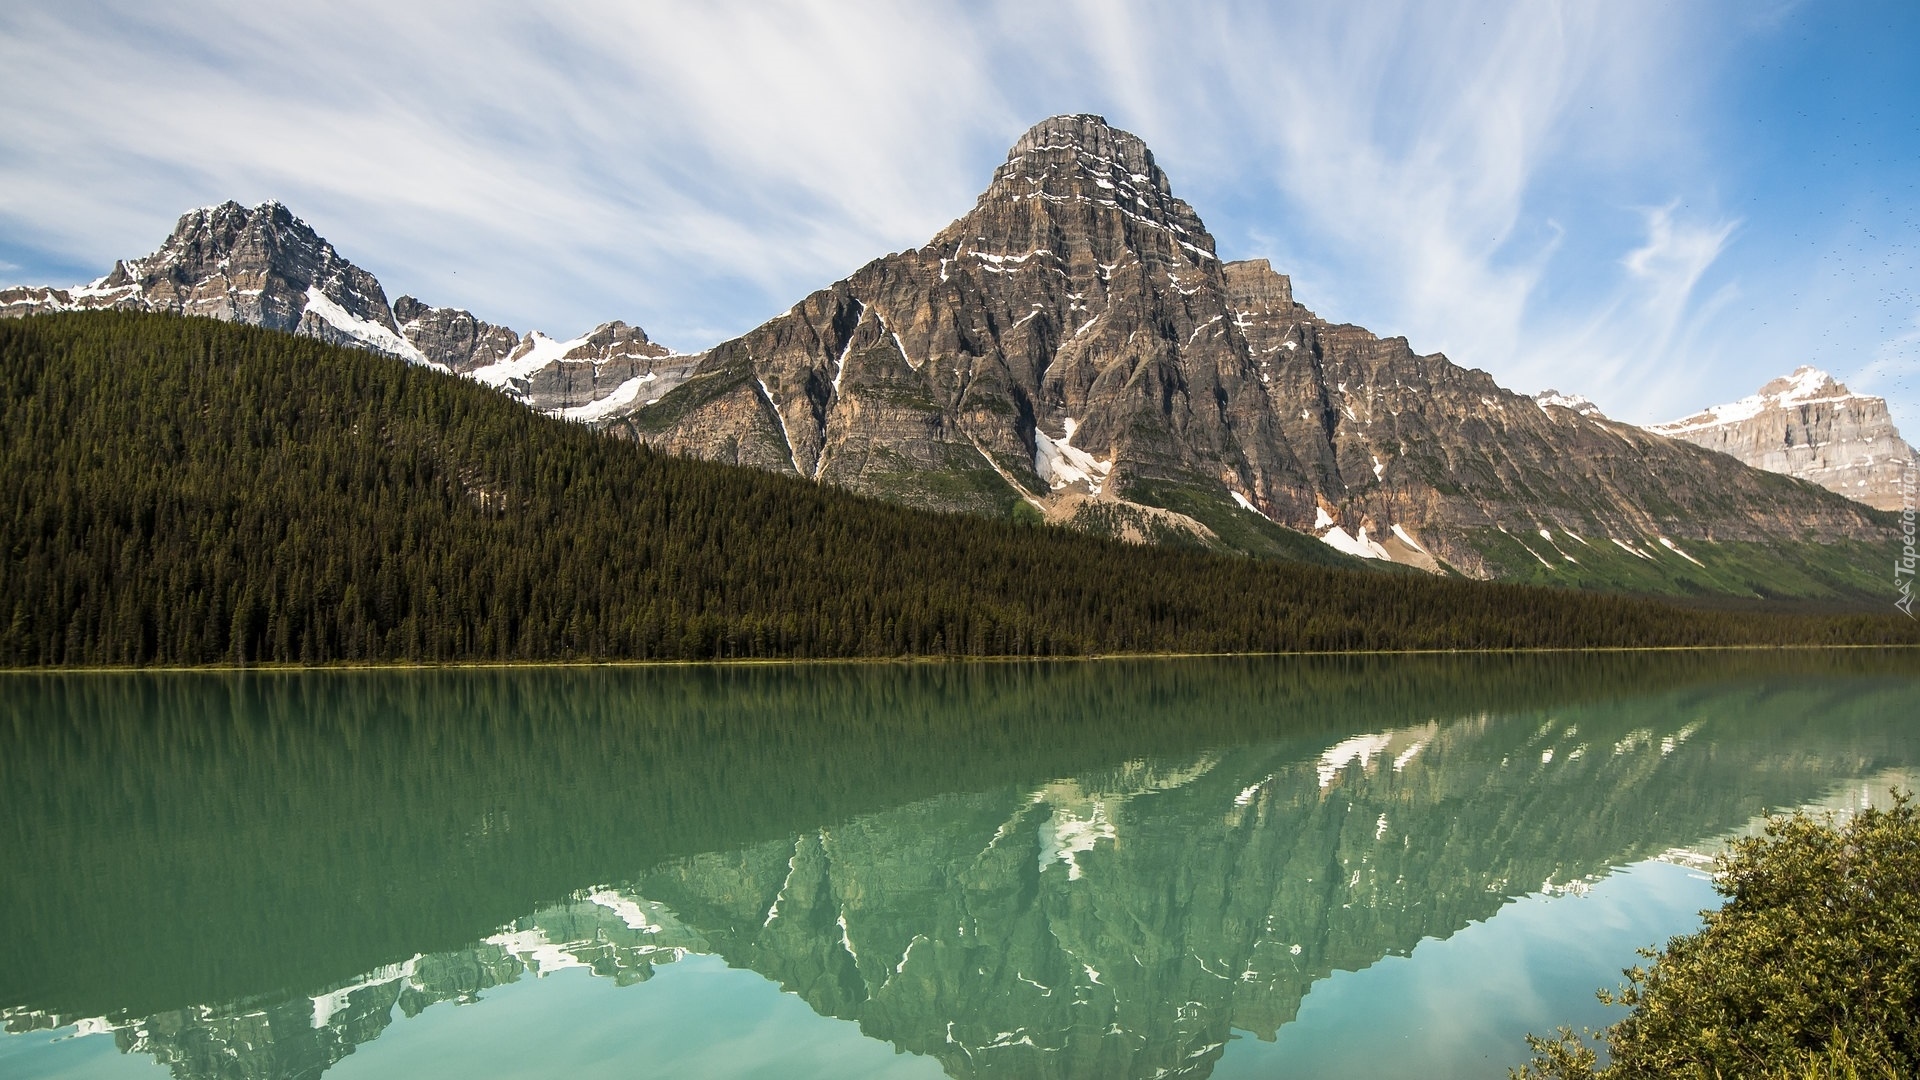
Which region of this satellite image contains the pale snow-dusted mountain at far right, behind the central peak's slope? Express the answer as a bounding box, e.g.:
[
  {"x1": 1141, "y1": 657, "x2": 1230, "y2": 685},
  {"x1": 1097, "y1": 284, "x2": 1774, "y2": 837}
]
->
[{"x1": 1649, "y1": 367, "x2": 1916, "y2": 509}]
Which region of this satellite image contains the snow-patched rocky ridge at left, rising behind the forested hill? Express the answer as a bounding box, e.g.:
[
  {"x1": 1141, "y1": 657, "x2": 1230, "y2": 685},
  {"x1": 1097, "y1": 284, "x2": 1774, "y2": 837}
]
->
[{"x1": 0, "y1": 202, "x2": 684, "y2": 419}]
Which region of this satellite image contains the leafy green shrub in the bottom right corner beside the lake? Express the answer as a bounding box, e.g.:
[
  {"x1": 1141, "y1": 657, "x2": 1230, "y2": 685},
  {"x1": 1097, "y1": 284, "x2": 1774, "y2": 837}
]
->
[{"x1": 1511, "y1": 794, "x2": 1920, "y2": 1080}]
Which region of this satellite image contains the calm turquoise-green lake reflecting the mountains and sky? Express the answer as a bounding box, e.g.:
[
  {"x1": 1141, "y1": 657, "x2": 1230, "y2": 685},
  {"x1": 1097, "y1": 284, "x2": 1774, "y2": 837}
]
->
[{"x1": 0, "y1": 651, "x2": 1920, "y2": 1080}]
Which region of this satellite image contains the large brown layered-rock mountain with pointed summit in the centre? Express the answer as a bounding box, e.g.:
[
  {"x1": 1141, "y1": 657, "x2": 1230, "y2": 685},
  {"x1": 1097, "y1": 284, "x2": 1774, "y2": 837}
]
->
[{"x1": 601, "y1": 115, "x2": 1885, "y2": 588}]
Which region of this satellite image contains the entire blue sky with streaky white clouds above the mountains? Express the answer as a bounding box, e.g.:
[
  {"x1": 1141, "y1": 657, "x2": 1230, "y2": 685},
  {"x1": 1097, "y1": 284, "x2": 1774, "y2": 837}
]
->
[{"x1": 0, "y1": 0, "x2": 1920, "y2": 428}]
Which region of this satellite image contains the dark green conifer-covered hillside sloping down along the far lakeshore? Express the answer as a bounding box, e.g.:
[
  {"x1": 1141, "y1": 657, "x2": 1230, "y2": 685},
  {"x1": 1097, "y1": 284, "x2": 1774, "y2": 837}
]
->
[{"x1": 0, "y1": 311, "x2": 1920, "y2": 665}]
